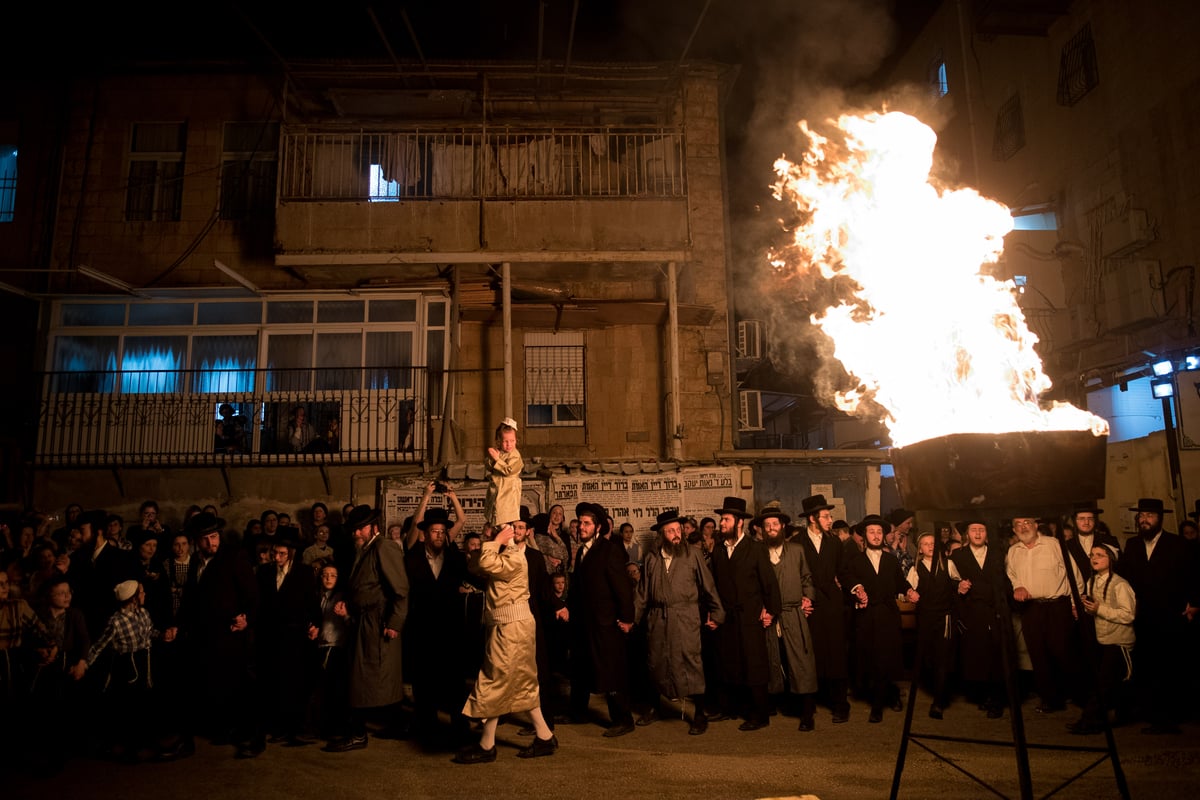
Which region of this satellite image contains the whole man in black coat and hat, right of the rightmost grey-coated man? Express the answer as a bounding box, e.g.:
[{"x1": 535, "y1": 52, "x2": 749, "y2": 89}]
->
[{"x1": 792, "y1": 494, "x2": 857, "y2": 722}]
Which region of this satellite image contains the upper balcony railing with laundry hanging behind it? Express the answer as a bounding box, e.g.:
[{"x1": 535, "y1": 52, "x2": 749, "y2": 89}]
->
[{"x1": 280, "y1": 127, "x2": 686, "y2": 201}]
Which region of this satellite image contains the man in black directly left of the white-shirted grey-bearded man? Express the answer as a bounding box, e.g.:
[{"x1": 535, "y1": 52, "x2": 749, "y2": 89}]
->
[{"x1": 946, "y1": 519, "x2": 1013, "y2": 720}]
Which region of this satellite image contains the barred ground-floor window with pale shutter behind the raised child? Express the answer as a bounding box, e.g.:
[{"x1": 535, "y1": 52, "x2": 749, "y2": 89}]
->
[{"x1": 524, "y1": 332, "x2": 587, "y2": 427}]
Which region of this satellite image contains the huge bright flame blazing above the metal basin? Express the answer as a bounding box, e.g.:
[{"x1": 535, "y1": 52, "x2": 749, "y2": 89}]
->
[{"x1": 772, "y1": 113, "x2": 1108, "y2": 446}]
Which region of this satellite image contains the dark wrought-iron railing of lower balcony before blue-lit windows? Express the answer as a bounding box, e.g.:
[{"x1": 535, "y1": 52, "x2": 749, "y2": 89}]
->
[{"x1": 35, "y1": 367, "x2": 444, "y2": 467}]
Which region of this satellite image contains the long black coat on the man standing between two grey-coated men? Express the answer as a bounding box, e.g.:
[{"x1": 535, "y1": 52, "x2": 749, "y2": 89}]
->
[{"x1": 713, "y1": 535, "x2": 782, "y2": 686}]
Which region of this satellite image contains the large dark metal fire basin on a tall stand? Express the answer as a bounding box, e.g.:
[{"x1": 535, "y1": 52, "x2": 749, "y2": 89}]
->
[{"x1": 892, "y1": 431, "x2": 1108, "y2": 512}]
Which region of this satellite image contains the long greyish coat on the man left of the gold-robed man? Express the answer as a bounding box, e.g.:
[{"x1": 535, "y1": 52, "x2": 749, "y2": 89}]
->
[{"x1": 346, "y1": 535, "x2": 408, "y2": 708}]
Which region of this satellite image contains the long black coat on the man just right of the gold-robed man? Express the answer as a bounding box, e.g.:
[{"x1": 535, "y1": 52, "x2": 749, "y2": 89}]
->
[{"x1": 568, "y1": 536, "x2": 634, "y2": 692}]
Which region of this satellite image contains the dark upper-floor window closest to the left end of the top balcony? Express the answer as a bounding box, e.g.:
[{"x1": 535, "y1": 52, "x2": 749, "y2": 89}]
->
[{"x1": 221, "y1": 122, "x2": 280, "y2": 219}]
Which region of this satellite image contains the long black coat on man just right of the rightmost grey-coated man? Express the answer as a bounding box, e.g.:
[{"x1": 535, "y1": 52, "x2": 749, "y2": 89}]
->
[{"x1": 788, "y1": 530, "x2": 850, "y2": 679}]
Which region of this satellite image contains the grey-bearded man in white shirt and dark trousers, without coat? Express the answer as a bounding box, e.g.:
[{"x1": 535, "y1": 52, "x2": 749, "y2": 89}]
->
[{"x1": 1004, "y1": 515, "x2": 1084, "y2": 714}]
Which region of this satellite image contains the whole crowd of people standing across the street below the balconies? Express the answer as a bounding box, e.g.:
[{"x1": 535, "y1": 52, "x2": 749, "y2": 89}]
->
[{"x1": 0, "y1": 491, "x2": 1200, "y2": 768}]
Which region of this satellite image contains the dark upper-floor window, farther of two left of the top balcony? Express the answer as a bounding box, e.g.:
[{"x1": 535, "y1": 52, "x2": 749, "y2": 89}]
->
[{"x1": 125, "y1": 122, "x2": 187, "y2": 222}]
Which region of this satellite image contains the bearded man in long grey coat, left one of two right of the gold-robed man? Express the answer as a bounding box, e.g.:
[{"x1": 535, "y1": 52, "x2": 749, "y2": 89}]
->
[{"x1": 635, "y1": 509, "x2": 725, "y2": 736}]
